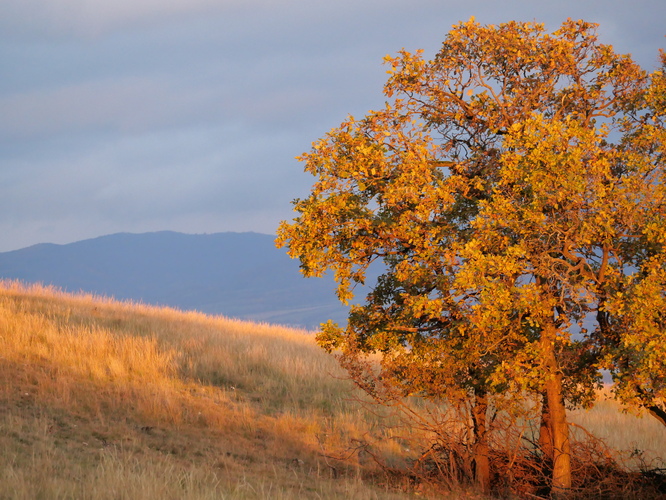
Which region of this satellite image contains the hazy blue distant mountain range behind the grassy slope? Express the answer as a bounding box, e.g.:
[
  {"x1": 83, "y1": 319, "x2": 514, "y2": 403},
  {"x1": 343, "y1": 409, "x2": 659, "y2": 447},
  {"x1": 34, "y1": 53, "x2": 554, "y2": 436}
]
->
[{"x1": 0, "y1": 231, "x2": 347, "y2": 328}]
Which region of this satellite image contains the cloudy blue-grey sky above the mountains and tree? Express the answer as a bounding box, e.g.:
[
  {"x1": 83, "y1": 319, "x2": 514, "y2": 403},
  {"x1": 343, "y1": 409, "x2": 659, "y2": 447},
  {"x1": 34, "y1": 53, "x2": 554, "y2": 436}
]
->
[{"x1": 0, "y1": 0, "x2": 666, "y2": 252}]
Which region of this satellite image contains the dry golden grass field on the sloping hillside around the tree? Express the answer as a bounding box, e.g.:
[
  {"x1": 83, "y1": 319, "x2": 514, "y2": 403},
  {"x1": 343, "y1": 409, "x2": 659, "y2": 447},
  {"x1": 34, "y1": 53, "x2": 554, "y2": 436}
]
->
[{"x1": 0, "y1": 282, "x2": 666, "y2": 499}]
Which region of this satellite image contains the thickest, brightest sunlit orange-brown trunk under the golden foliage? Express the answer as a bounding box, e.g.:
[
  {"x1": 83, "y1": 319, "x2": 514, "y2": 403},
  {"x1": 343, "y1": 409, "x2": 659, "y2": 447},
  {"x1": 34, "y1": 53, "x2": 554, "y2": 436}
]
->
[{"x1": 542, "y1": 327, "x2": 571, "y2": 498}]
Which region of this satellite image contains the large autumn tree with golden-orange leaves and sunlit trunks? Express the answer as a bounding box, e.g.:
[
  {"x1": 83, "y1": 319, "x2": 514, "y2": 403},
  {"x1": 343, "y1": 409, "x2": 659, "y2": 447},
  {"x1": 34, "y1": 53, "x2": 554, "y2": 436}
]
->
[{"x1": 278, "y1": 19, "x2": 666, "y2": 494}]
